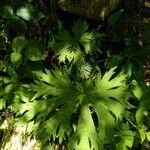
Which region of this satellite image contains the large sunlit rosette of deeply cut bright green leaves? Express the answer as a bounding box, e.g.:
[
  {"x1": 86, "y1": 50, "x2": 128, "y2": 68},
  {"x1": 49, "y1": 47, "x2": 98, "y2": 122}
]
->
[{"x1": 12, "y1": 68, "x2": 127, "y2": 150}]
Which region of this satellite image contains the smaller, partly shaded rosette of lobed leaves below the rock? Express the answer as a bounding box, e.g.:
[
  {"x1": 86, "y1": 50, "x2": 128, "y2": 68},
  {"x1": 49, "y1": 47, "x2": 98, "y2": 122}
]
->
[{"x1": 53, "y1": 21, "x2": 96, "y2": 62}]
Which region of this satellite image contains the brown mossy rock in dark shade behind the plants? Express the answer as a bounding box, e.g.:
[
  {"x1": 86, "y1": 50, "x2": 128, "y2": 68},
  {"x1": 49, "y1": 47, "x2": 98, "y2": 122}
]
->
[{"x1": 58, "y1": 0, "x2": 119, "y2": 20}]
